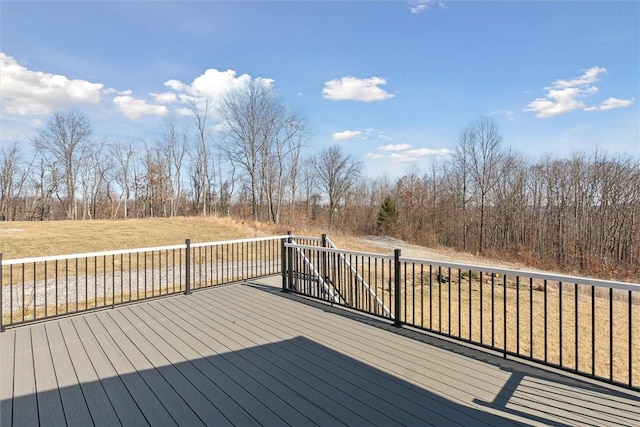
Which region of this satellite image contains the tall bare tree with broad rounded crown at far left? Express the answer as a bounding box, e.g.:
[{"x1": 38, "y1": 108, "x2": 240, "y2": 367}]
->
[{"x1": 32, "y1": 111, "x2": 93, "y2": 219}]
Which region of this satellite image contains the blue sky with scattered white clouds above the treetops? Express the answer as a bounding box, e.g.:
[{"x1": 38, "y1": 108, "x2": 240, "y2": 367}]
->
[{"x1": 0, "y1": 1, "x2": 640, "y2": 176}]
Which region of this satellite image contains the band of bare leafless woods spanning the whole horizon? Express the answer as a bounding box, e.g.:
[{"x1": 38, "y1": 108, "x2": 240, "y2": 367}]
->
[{"x1": 0, "y1": 106, "x2": 640, "y2": 280}]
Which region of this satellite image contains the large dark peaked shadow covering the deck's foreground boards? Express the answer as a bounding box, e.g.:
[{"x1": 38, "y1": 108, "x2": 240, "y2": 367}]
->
[{"x1": 5, "y1": 337, "x2": 524, "y2": 426}]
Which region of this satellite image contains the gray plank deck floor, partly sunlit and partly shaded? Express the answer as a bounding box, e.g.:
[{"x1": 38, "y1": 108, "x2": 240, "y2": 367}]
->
[{"x1": 0, "y1": 282, "x2": 640, "y2": 427}]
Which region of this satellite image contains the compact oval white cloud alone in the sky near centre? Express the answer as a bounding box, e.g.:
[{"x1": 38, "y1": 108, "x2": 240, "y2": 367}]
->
[{"x1": 322, "y1": 77, "x2": 394, "y2": 102}]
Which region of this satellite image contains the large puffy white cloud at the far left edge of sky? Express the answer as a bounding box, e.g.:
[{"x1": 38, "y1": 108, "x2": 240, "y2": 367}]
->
[{"x1": 0, "y1": 52, "x2": 104, "y2": 115}]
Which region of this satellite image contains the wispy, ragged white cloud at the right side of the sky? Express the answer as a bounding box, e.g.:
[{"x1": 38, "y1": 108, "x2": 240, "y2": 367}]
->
[{"x1": 524, "y1": 67, "x2": 633, "y2": 118}]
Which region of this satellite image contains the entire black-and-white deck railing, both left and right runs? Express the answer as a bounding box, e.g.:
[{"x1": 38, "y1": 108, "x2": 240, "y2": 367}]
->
[{"x1": 0, "y1": 234, "x2": 640, "y2": 390}]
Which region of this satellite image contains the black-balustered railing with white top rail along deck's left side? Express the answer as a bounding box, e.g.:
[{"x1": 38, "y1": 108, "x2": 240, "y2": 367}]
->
[{"x1": 0, "y1": 236, "x2": 283, "y2": 328}]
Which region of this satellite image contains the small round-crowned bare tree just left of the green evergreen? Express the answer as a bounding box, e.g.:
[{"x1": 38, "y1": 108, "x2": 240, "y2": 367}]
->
[{"x1": 314, "y1": 145, "x2": 362, "y2": 225}]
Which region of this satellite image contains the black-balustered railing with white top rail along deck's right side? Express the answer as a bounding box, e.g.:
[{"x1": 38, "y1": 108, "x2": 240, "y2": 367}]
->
[{"x1": 283, "y1": 242, "x2": 640, "y2": 390}]
